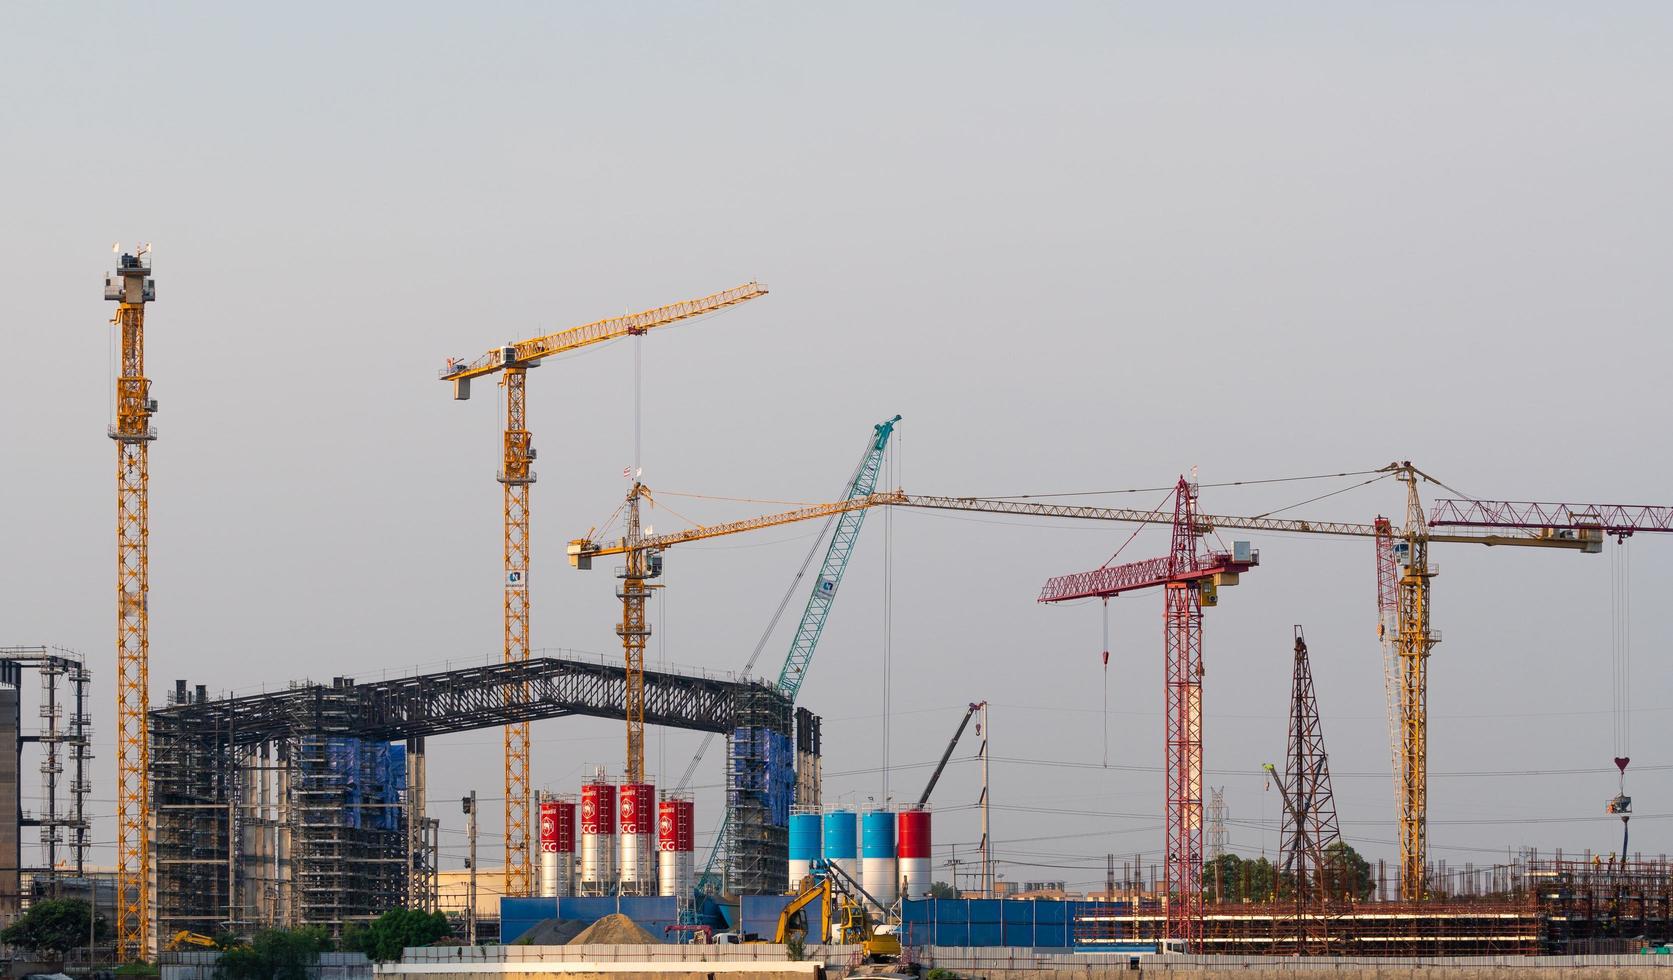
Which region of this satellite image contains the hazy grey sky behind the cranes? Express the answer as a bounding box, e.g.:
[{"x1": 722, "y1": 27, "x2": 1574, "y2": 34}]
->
[{"x1": 0, "y1": 3, "x2": 1673, "y2": 886}]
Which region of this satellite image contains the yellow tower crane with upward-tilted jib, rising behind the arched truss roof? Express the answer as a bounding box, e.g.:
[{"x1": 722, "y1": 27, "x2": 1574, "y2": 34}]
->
[{"x1": 440, "y1": 283, "x2": 766, "y2": 896}]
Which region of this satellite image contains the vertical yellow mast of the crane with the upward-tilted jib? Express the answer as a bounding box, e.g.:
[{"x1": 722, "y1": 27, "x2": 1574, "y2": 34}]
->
[{"x1": 499, "y1": 366, "x2": 535, "y2": 896}]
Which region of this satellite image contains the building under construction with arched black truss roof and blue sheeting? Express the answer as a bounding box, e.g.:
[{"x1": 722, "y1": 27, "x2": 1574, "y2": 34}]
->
[{"x1": 151, "y1": 657, "x2": 813, "y2": 935}]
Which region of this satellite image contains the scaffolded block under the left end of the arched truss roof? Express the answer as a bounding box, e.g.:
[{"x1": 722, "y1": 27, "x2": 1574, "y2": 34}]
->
[{"x1": 152, "y1": 677, "x2": 416, "y2": 935}]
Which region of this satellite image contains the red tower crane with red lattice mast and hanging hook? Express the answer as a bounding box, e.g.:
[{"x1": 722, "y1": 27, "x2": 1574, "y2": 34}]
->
[{"x1": 1039, "y1": 477, "x2": 1260, "y2": 942}]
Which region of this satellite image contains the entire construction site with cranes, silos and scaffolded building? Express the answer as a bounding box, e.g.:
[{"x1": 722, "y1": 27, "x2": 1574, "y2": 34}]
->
[{"x1": 0, "y1": 248, "x2": 1646, "y2": 960}]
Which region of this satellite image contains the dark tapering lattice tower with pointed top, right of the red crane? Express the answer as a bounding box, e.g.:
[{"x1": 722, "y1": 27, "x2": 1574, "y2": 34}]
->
[{"x1": 1280, "y1": 627, "x2": 1342, "y2": 945}]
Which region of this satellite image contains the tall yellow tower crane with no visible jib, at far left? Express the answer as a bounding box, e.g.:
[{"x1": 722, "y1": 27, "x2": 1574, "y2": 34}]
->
[{"x1": 105, "y1": 244, "x2": 157, "y2": 960}]
